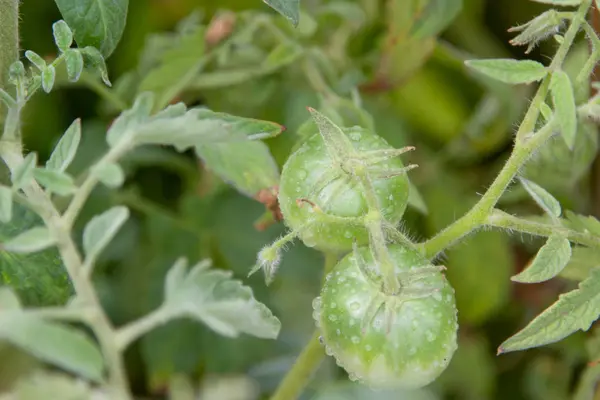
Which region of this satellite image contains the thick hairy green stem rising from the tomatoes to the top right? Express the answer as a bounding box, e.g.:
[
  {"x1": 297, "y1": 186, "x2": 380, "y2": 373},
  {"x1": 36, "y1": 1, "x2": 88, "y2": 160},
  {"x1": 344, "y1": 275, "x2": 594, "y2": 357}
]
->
[{"x1": 419, "y1": 0, "x2": 592, "y2": 258}]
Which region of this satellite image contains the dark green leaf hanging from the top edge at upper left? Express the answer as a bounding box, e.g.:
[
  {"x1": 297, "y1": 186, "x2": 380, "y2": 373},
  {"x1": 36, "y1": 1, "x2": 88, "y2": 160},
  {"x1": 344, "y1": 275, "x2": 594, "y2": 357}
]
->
[{"x1": 55, "y1": 0, "x2": 129, "y2": 57}]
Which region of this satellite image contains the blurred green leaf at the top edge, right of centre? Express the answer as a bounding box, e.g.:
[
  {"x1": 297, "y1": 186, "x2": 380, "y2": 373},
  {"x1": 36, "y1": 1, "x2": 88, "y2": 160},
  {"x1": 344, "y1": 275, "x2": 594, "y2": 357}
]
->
[{"x1": 411, "y1": 0, "x2": 463, "y2": 39}]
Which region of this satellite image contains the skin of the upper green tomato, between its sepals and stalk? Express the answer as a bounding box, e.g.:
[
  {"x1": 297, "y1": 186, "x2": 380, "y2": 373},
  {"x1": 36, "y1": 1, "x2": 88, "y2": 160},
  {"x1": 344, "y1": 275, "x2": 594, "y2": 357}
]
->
[{"x1": 278, "y1": 128, "x2": 409, "y2": 251}]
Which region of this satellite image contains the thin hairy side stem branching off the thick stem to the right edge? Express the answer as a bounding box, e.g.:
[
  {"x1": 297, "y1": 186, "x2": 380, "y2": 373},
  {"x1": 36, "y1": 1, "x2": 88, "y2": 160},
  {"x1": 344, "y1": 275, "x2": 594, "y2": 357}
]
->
[{"x1": 485, "y1": 210, "x2": 600, "y2": 248}]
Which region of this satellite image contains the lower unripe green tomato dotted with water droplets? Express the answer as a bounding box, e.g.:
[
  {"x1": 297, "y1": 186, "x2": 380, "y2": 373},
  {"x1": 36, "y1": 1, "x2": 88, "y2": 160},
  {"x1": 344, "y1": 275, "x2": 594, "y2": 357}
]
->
[{"x1": 313, "y1": 245, "x2": 458, "y2": 388}]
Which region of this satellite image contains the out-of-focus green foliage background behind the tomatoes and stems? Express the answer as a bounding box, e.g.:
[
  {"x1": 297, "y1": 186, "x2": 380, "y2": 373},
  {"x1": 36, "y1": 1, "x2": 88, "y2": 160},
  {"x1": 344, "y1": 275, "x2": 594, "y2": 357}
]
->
[{"x1": 0, "y1": 0, "x2": 600, "y2": 400}]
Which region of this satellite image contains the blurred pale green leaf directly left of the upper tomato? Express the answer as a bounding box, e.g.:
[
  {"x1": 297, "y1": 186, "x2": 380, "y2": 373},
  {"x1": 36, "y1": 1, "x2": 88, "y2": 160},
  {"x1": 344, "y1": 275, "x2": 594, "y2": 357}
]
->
[{"x1": 196, "y1": 142, "x2": 279, "y2": 197}]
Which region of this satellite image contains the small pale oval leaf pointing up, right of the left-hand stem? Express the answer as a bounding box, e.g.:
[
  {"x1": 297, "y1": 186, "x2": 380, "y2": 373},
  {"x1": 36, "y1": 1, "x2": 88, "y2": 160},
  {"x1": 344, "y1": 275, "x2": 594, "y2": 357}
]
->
[{"x1": 83, "y1": 206, "x2": 129, "y2": 265}]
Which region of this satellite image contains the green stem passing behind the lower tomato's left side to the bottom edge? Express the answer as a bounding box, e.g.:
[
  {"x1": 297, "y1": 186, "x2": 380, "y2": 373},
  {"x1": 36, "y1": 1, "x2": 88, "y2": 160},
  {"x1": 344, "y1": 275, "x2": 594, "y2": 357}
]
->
[{"x1": 271, "y1": 253, "x2": 338, "y2": 400}]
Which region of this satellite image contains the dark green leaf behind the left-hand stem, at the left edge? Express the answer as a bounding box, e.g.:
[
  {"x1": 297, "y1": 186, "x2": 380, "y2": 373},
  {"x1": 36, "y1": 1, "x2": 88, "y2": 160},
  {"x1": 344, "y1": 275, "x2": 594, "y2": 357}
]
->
[{"x1": 0, "y1": 204, "x2": 72, "y2": 306}]
